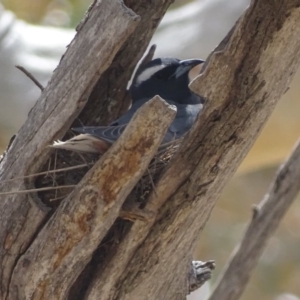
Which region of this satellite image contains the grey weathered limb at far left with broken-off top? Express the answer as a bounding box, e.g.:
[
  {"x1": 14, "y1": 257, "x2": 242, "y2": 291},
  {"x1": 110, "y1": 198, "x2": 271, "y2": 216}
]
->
[{"x1": 0, "y1": 0, "x2": 139, "y2": 299}]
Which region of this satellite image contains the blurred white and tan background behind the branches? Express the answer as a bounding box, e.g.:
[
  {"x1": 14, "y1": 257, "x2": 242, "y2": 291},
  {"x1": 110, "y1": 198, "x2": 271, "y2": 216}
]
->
[{"x1": 0, "y1": 0, "x2": 300, "y2": 300}]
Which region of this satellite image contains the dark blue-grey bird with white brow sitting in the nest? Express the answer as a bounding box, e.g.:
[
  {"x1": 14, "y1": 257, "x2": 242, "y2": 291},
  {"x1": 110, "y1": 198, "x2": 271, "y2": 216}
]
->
[{"x1": 50, "y1": 58, "x2": 204, "y2": 155}]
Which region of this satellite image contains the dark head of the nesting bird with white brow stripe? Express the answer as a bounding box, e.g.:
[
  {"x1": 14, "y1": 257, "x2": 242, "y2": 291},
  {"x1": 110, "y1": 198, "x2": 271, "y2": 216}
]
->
[{"x1": 130, "y1": 58, "x2": 204, "y2": 104}]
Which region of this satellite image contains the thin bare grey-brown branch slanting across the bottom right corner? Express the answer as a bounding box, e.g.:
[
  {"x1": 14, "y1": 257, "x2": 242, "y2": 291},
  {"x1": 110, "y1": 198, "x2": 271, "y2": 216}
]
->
[{"x1": 209, "y1": 140, "x2": 300, "y2": 300}]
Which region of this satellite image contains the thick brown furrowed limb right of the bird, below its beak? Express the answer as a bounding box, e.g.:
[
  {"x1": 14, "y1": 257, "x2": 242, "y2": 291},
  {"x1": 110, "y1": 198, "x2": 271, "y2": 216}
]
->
[{"x1": 82, "y1": 0, "x2": 300, "y2": 300}]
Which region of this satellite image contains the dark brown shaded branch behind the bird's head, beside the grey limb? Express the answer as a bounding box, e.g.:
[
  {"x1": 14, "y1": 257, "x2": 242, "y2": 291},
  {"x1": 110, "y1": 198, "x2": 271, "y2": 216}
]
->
[{"x1": 79, "y1": 0, "x2": 174, "y2": 126}]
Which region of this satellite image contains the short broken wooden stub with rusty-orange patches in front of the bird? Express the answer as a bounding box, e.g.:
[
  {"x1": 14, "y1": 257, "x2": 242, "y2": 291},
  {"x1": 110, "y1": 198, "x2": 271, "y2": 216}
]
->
[{"x1": 9, "y1": 96, "x2": 176, "y2": 299}]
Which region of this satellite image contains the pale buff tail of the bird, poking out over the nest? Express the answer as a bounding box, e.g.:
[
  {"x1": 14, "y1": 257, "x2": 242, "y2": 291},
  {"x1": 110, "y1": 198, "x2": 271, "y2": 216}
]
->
[{"x1": 49, "y1": 134, "x2": 111, "y2": 154}]
